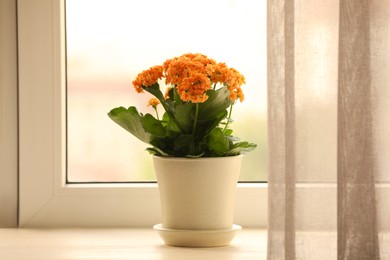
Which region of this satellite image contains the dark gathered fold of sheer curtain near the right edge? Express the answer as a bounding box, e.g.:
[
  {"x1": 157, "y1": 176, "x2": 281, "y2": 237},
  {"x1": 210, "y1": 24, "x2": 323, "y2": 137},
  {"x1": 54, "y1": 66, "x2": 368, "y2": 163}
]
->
[{"x1": 337, "y1": 0, "x2": 379, "y2": 260}]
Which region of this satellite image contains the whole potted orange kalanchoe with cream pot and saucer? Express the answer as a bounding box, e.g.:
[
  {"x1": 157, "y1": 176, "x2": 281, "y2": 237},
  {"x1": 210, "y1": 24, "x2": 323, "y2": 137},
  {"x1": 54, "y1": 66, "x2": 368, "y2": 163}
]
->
[{"x1": 108, "y1": 53, "x2": 256, "y2": 246}]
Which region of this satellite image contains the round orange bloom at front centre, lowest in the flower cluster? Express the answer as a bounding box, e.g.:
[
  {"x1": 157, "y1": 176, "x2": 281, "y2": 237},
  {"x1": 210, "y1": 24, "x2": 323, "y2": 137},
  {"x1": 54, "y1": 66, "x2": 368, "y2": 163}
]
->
[{"x1": 177, "y1": 73, "x2": 211, "y2": 103}]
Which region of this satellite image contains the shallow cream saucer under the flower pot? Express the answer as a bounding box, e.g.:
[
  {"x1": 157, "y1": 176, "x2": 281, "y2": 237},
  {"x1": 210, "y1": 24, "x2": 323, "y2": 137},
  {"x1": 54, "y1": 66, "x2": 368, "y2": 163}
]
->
[{"x1": 153, "y1": 224, "x2": 242, "y2": 247}]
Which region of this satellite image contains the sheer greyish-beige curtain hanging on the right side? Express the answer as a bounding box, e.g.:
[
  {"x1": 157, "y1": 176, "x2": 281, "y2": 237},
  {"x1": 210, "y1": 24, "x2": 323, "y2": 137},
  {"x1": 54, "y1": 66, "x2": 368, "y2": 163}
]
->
[{"x1": 268, "y1": 0, "x2": 390, "y2": 260}]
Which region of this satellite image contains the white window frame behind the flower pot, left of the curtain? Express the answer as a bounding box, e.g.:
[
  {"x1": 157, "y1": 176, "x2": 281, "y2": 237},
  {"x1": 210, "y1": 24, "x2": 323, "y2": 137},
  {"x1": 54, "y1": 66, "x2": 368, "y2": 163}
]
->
[{"x1": 18, "y1": 0, "x2": 267, "y2": 227}]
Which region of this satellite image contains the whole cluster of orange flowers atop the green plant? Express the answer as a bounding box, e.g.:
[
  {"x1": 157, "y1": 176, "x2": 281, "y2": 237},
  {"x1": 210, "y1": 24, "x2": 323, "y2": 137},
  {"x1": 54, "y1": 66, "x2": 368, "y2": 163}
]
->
[{"x1": 133, "y1": 53, "x2": 245, "y2": 103}]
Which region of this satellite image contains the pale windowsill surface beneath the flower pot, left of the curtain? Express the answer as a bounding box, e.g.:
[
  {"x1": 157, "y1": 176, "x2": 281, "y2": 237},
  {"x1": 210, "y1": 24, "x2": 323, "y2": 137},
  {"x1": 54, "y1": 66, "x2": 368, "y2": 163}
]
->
[{"x1": 0, "y1": 228, "x2": 267, "y2": 260}]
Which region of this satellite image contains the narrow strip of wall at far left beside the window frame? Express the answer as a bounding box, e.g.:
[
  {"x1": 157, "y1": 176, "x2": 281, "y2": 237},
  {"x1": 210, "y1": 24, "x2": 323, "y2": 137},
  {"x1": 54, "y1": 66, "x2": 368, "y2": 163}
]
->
[{"x1": 0, "y1": 0, "x2": 18, "y2": 227}]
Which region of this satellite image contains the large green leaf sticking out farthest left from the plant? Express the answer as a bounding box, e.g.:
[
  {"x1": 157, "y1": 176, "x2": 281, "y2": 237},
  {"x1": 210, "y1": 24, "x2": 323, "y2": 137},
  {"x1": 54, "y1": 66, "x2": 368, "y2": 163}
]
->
[{"x1": 108, "y1": 107, "x2": 151, "y2": 143}]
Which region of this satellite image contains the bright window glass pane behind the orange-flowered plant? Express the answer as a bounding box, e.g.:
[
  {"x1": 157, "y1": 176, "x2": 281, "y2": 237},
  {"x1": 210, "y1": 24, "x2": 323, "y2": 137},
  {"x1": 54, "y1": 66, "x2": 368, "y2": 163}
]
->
[{"x1": 66, "y1": 0, "x2": 267, "y2": 182}]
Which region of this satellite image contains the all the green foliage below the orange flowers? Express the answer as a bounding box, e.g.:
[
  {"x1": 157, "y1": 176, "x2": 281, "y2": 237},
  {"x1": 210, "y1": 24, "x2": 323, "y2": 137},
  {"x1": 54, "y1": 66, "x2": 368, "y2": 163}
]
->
[{"x1": 108, "y1": 84, "x2": 256, "y2": 157}]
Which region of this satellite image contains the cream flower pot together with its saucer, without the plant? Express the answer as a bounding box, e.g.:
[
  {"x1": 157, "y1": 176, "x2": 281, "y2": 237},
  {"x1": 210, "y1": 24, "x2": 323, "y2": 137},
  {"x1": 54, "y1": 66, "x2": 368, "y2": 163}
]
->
[{"x1": 153, "y1": 155, "x2": 242, "y2": 246}]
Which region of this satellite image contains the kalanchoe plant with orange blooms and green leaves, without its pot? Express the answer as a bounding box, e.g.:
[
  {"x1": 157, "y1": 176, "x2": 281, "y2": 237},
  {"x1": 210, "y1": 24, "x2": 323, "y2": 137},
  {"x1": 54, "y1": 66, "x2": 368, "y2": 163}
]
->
[{"x1": 108, "y1": 53, "x2": 256, "y2": 157}]
